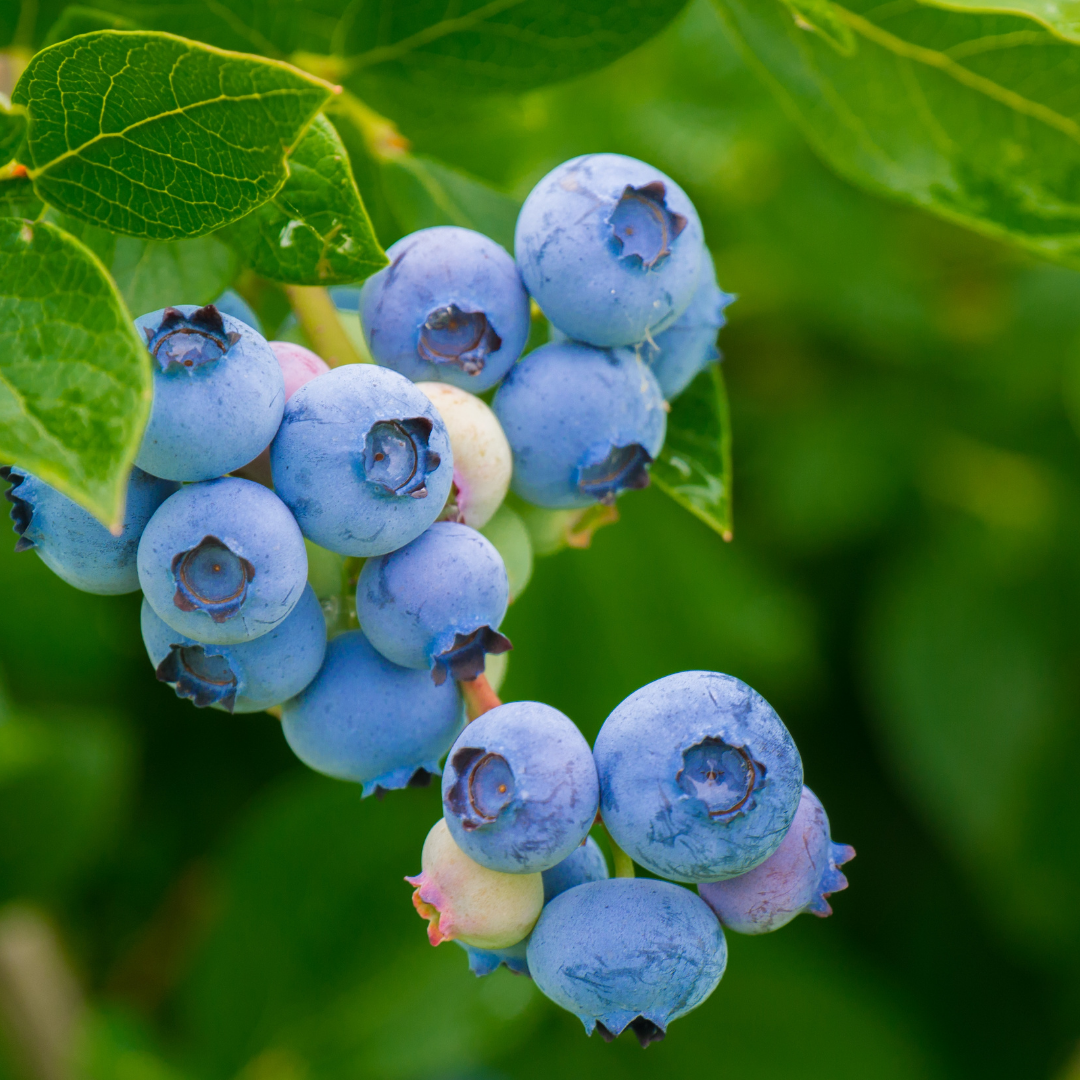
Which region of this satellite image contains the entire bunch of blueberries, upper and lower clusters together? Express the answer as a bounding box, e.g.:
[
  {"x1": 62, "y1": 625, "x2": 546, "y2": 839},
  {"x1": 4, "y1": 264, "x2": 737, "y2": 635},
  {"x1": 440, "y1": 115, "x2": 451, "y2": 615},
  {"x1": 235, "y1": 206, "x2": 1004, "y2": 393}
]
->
[{"x1": 2, "y1": 154, "x2": 851, "y2": 1043}]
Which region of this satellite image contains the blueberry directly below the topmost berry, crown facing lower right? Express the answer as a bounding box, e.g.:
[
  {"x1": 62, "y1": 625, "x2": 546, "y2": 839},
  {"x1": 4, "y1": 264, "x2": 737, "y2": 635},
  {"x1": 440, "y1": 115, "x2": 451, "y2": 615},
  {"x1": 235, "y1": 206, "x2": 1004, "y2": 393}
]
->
[{"x1": 494, "y1": 341, "x2": 667, "y2": 510}]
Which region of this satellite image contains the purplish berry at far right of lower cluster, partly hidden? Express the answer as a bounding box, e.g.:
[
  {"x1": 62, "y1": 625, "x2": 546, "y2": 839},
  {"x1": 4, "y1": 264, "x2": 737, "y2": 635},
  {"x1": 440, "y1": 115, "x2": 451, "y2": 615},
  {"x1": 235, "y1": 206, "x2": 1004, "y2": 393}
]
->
[{"x1": 698, "y1": 787, "x2": 855, "y2": 934}]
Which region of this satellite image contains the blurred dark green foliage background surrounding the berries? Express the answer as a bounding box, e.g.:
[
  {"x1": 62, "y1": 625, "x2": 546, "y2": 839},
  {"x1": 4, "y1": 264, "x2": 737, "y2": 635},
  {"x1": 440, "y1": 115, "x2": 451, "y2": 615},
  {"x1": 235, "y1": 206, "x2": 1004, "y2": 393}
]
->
[{"x1": 0, "y1": 0, "x2": 1080, "y2": 1080}]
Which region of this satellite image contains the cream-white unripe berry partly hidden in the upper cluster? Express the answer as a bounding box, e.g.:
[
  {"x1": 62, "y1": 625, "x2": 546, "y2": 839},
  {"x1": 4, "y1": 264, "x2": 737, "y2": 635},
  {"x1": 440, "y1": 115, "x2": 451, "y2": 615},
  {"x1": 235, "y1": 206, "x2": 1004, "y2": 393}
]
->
[{"x1": 417, "y1": 382, "x2": 512, "y2": 529}]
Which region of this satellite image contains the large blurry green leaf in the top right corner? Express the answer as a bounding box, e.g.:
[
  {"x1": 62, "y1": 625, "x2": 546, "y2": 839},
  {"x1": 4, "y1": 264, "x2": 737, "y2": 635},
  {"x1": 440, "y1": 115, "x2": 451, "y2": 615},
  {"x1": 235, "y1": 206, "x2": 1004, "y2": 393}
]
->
[{"x1": 715, "y1": 0, "x2": 1080, "y2": 266}]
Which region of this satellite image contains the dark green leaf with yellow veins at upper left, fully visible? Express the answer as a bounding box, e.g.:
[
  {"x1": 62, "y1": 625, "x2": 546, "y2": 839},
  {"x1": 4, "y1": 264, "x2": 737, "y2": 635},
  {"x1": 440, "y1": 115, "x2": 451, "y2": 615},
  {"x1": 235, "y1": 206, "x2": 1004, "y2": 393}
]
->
[{"x1": 13, "y1": 30, "x2": 330, "y2": 240}]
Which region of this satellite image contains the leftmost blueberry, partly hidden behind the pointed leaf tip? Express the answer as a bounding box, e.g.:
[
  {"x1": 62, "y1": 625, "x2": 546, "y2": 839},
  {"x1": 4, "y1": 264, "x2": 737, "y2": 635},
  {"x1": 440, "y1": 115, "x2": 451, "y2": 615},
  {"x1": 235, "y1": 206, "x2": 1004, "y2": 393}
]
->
[{"x1": 0, "y1": 465, "x2": 179, "y2": 596}]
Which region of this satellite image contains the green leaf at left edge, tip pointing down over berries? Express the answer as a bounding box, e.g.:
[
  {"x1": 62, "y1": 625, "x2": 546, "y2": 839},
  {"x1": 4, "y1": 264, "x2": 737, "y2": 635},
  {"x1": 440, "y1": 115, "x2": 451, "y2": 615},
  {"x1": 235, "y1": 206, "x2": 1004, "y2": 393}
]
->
[{"x1": 0, "y1": 218, "x2": 151, "y2": 524}]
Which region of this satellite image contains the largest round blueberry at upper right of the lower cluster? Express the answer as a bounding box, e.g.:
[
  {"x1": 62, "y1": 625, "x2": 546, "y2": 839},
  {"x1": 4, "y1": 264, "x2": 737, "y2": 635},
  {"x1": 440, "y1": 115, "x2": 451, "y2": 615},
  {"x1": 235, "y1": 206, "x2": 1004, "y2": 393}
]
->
[{"x1": 594, "y1": 672, "x2": 802, "y2": 882}]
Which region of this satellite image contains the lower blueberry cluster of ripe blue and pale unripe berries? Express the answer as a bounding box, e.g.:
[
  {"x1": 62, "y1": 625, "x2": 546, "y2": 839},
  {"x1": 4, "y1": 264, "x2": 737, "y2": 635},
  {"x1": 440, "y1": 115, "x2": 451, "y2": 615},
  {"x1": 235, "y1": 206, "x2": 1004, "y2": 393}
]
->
[{"x1": 406, "y1": 672, "x2": 854, "y2": 1047}]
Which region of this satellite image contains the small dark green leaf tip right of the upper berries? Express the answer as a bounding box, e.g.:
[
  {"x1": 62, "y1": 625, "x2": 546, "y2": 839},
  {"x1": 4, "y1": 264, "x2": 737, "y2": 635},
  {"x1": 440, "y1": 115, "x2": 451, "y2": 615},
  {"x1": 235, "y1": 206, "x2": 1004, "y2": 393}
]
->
[{"x1": 649, "y1": 364, "x2": 731, "y2": 540}]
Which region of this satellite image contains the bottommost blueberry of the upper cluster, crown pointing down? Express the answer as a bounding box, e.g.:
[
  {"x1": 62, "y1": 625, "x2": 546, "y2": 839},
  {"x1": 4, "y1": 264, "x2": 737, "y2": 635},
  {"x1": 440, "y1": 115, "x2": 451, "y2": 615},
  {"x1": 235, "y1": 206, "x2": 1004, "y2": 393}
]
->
[{"x1": 282, "y1": 630, "x2": 464, "y2": 796}]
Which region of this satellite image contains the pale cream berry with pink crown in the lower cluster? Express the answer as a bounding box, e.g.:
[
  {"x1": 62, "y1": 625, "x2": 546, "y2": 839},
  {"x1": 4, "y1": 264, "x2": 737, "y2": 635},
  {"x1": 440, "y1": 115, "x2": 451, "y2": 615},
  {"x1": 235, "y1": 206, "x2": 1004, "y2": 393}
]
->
[{"x1": 405, "y1": 821, "x2": 544, "y2": 950}]
